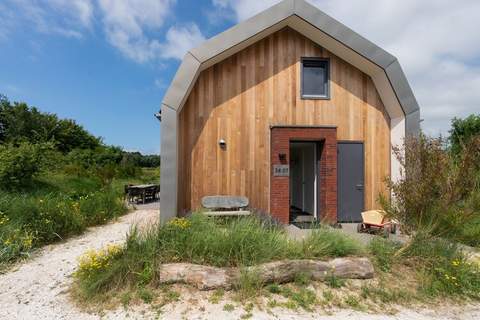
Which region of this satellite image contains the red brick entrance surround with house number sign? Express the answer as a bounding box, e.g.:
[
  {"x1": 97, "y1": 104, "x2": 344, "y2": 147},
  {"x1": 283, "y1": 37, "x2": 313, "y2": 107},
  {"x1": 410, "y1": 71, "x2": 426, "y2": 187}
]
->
[{"x1": 270, "y1": 125, "x2": 337, "y2": 224}]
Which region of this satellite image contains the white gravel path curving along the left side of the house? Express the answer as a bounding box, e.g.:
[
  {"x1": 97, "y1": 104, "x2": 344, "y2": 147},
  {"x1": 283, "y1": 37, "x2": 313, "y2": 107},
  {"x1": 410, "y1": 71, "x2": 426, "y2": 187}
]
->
[{"x1": 0, "y1": 210, "x2": 159, "y2": 319}]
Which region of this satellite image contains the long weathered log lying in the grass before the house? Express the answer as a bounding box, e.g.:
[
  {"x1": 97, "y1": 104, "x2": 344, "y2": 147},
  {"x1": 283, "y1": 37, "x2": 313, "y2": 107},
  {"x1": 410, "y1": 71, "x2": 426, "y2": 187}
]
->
[{"x1": 160, "y1": 258, "x2": 374, "y2": 290}]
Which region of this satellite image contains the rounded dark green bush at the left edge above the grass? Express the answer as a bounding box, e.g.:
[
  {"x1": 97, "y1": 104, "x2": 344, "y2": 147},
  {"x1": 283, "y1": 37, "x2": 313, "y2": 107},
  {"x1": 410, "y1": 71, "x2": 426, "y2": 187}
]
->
[{"x1": 0, "y1": 142, "x2": 51, "y2": 189}]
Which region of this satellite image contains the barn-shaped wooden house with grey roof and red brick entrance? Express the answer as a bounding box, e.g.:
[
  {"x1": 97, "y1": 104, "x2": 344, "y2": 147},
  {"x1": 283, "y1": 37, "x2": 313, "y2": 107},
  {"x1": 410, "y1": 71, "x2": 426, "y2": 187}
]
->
[{"x1": 160, "y1": 0, "x2": 420, "y2": 223}]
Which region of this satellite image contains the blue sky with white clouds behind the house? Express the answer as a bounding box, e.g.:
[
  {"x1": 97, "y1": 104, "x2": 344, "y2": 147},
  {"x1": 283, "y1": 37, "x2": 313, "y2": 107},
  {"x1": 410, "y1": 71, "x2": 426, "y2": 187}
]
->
[{"x1": 0, "y1": 0, "x2": 480, "y2": 154}]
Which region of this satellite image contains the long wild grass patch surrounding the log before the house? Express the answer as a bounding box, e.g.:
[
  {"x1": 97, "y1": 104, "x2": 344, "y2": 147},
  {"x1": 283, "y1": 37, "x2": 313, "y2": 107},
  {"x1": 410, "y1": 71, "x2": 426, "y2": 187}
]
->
[{"x1": 70, "y1": 208, "x2": 480, "y2": 316}]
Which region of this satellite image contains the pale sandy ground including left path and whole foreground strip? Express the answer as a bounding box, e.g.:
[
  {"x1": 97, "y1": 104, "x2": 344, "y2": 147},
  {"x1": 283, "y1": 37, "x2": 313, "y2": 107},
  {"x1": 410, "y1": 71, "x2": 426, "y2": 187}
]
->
[{"x1": 0, "y1": 209, "x2": 480, "y2": 320}]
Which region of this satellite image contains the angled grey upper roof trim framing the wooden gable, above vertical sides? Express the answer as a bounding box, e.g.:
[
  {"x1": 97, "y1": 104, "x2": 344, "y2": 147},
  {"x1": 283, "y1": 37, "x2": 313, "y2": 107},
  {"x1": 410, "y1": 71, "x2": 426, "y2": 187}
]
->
[{"x1": 163, "y1": 0, "x2": 419, "y2": 129}]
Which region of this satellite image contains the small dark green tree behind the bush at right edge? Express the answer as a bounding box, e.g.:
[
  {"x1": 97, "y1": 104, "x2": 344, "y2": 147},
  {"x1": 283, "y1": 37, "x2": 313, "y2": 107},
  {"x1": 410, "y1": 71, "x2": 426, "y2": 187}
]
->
[{"x1": 449, "y1": 114, "x2": 480, "y2": 154}]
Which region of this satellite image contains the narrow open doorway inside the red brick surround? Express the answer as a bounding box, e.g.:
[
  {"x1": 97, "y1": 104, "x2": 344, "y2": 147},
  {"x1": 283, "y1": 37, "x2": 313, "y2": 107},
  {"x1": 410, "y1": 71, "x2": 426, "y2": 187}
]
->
[{"x1": 289, "y1": 141, "x2": 318, "y2": 222}]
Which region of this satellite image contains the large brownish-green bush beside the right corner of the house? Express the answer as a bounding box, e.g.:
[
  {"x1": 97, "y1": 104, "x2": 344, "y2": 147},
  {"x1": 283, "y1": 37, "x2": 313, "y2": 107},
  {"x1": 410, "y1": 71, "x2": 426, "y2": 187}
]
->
[{"x1": 381, "y1": 135, "x2": 480, "y2": 244}]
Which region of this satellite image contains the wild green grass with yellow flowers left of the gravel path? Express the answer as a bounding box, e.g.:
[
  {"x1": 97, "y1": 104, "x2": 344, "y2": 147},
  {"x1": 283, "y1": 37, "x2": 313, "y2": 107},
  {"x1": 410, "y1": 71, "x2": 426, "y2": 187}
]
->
[{"x1": 0, "y1": 169, "x2": 158, "y2": 272}]
